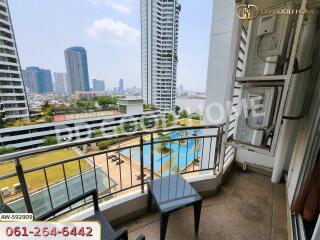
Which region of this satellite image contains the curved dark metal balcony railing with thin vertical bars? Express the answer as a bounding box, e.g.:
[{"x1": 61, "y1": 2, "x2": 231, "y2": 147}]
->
[{"x1": 0, "y1": 125, "x2": 232, "y2": 217}]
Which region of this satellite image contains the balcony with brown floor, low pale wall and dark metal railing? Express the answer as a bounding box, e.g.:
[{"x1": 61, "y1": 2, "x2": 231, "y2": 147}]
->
[{"x1": 0, "y1": 125, "x2": 287, "y2": 239}]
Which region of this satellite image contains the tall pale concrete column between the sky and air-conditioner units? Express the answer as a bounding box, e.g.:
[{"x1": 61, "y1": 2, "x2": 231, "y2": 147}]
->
[{"x1": 202, "y1": 0, "x2": 239, "y2": 169}]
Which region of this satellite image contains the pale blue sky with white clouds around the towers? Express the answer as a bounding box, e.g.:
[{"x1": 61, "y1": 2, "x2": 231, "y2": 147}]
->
[{"x1": 8, "y1": 0, "x2": 213, "y2": 91}]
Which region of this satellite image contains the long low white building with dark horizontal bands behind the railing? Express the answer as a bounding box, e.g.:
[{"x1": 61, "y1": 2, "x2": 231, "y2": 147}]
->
[{"x1": 0, "y1": 111, "x2": 162, "y2": 150}]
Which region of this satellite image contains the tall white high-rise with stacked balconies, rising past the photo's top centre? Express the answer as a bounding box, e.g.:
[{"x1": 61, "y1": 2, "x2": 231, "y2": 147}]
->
[{"x1": 140, "y1": 0, "x2": 181, "y2": 111}]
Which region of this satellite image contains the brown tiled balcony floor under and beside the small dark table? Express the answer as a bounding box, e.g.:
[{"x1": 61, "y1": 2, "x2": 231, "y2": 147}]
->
[{"x1": 121, "y1": 169, "x2": 288, "y2": 240}]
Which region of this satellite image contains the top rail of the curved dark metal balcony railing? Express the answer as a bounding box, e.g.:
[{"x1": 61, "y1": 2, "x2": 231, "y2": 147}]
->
[{"x1": 0, "y1": 123, "x2": 225, "y2": 163}]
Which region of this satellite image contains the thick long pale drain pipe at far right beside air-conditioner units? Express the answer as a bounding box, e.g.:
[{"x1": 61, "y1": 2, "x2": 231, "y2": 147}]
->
[{"x1": 271, "y1": 15, "x2": 317, "y2": 183}]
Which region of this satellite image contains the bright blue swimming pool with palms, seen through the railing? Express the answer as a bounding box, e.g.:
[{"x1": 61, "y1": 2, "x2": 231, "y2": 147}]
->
[{"x1": 121, "y1": 131, "x2": 202, "y2": 176}]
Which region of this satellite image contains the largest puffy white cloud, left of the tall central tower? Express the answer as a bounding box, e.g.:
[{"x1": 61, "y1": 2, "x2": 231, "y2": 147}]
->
[{"x1": 86, "y1": 18, "x2": 140, "y2": 46}]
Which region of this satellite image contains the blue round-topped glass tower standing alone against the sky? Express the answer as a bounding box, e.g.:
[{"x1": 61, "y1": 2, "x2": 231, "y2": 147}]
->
[{"x1": 64, "y1": 47, "x2": 90, "y2": 95}]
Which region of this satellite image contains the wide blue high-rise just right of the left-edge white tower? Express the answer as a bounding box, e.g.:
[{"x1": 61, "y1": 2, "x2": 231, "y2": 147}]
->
[{"x1": 22, "y1": 67, "x2": 53, "y2": 94}]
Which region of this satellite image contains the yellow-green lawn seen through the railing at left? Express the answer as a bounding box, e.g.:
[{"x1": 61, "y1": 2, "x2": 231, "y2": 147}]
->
[{"x1": 0, "y1": 149, "x2": 91, "y2": 197}]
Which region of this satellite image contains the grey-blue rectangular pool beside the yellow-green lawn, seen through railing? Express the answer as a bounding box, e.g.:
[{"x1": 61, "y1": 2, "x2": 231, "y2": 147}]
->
[{"x1": 8, "y1": 168, "x2": 116, "y2": 217}]
